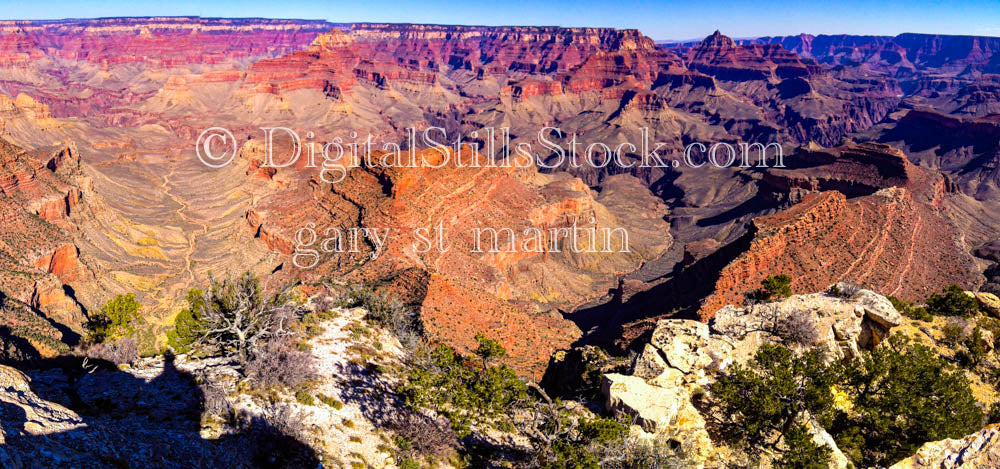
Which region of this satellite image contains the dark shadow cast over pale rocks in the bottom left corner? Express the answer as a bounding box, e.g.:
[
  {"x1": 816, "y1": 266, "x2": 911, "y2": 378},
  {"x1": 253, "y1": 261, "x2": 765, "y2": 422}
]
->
[{"x1": 0, "y1": 355, "x2": 321, "y2": 469}]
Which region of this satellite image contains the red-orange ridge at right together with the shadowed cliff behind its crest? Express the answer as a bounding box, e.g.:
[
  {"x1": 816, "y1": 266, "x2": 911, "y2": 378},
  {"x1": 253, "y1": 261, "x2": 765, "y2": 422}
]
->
[{"x1": 699, "y1": 144, "x2": 981, "y2": 318}]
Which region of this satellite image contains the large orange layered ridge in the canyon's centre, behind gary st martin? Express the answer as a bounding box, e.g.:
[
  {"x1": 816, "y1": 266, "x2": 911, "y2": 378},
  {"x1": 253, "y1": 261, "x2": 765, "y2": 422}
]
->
[{"x1": 238, "y1": 144, "x2": 671, "y2": 372}]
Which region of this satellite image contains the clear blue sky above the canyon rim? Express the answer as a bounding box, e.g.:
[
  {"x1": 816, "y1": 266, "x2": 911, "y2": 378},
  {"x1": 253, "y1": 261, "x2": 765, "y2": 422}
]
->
[{"x1": 0, "y1": 0, "x2": 1000, "y2": 40}]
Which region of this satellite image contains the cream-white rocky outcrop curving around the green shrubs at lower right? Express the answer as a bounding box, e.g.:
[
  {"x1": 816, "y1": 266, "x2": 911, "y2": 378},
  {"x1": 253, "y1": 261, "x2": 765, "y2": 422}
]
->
[{"x1": 602, "y1": 284, "x2": 902, "y2": 467}]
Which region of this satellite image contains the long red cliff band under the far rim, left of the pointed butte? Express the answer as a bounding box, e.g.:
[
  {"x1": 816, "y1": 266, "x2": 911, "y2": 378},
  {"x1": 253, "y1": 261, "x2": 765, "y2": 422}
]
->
[{"x1": 247, "y1": 24, "x2": 680, "y2": 97}]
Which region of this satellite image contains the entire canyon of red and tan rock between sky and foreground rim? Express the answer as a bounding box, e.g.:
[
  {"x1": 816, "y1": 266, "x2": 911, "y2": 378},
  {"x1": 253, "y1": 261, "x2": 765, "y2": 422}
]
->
[{"x1": 0, "y1": 17, "x2": 1000, "y2": 377}]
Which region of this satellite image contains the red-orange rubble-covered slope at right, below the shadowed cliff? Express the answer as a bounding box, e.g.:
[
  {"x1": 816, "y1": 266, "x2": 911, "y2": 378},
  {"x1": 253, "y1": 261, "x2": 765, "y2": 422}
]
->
[{"x1": 699, "y1": 179, "x2": 979, "y2": 319}]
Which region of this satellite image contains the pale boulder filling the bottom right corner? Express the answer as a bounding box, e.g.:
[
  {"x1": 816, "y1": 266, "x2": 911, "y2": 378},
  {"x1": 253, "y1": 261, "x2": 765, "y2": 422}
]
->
[{"x1": 889, "y1": 424, "x2": 1000, "y2": 469}]
